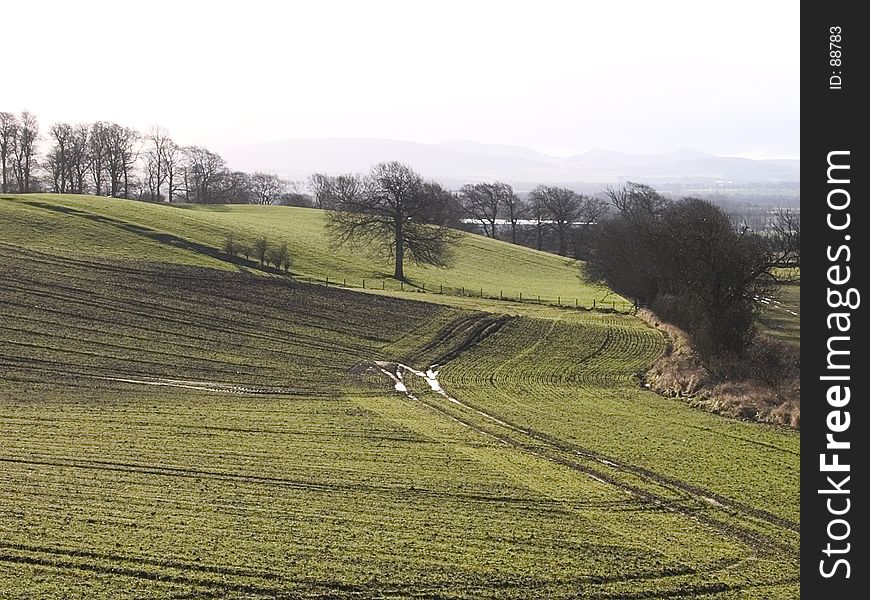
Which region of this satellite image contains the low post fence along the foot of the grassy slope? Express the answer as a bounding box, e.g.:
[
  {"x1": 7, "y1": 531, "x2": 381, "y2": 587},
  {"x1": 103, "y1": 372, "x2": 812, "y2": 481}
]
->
[{"x1": 294, "y1": 275, "x2": 635, "y2": 313}]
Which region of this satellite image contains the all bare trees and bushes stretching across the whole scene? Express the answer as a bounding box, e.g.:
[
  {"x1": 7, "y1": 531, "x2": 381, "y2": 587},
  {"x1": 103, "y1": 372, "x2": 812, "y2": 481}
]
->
[{"x1": 0, "y1": 112, "x2": 800, "y2": 364}]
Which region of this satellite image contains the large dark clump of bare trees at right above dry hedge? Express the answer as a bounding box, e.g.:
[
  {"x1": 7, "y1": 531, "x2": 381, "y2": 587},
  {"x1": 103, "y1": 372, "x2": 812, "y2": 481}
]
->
[{"x1": 584, "y1": 182, "x2": 800, "y2": 360}]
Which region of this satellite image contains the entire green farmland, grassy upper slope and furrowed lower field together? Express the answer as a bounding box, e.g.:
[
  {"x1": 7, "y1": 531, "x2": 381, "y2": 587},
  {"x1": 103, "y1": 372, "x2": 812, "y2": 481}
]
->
[{"x1": 0, "y1": 196, "x2": 800, "y2": 600}]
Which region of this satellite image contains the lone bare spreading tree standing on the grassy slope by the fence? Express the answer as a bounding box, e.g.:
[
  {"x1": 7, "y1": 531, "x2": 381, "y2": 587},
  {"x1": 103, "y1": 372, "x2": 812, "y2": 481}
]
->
[{"x1": 327, "y1": 161, "x2": 459, "y2": 281}]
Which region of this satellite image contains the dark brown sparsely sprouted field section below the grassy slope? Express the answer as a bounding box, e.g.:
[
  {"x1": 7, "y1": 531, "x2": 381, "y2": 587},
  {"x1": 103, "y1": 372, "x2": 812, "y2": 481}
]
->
[{"x1": 0, "y1": 246, "x2": 449, "y2": 394}]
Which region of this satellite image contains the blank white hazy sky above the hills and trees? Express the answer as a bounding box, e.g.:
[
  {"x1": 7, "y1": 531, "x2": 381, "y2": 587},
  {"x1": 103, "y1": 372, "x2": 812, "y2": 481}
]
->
[{"x1": 0, "y1": 0, "x2": 800, "y2": 158}]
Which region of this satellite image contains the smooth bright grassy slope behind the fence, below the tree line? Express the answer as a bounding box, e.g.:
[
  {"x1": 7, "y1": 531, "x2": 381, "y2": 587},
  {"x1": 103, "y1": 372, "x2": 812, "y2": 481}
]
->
[{"x1": 0, "y1": 194, "x2": 623, "y2": 306}]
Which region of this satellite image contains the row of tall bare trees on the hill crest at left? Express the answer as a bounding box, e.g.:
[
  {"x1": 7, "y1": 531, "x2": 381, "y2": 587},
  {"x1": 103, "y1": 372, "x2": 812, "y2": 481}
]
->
[{"x1": 0, "y1": 112, "x2": 306, "y2": 204}]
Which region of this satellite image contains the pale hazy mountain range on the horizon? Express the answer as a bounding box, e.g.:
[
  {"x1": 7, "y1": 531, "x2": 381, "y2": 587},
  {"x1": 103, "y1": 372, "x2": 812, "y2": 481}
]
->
[{"x1": 222, "y1": 138, "x2": 800, "y2": 185}]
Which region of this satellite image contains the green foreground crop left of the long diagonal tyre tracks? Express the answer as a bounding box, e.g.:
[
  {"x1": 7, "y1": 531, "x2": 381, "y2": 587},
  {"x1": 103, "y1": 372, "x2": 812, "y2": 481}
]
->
[{"x1": 0, "y1": 390, "x2": 768, "y2": 597}]
